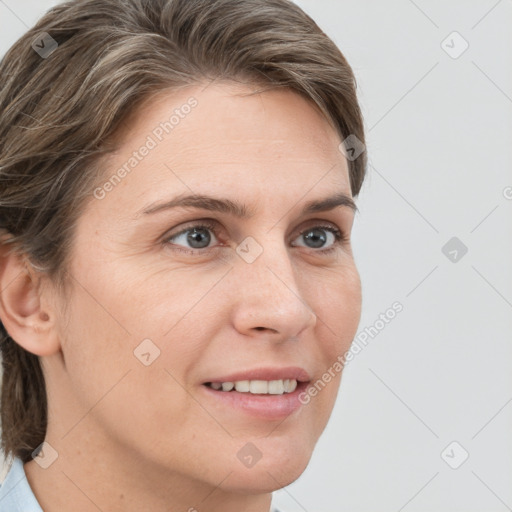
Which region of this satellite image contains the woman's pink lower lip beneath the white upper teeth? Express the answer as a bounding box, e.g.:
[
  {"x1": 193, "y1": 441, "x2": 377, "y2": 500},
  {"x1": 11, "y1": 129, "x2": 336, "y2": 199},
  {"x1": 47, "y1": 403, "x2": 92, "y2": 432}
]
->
[{"x1": 201, "y1": 382, "x2": 308, "y2": 420}]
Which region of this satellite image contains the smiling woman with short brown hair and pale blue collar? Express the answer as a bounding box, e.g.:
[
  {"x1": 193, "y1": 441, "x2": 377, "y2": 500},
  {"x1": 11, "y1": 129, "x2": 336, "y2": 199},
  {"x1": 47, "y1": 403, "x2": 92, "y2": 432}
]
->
[{"x1": 0, "y1": 0, "x2": 366, "y2": 512}]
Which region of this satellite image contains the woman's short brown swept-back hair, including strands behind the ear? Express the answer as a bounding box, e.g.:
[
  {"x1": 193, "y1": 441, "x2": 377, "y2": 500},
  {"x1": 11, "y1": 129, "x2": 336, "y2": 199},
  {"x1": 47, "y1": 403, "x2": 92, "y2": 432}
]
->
[{"x1": 0, "y1": 0, "x2": 367, "y2": 462}]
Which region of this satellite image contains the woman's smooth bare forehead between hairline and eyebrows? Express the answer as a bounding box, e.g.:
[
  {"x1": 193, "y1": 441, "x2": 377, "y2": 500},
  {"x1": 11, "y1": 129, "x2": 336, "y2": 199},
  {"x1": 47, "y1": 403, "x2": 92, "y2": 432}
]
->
[{"x1": 90, "y1": 82, "x2": 350, "y2": 218}]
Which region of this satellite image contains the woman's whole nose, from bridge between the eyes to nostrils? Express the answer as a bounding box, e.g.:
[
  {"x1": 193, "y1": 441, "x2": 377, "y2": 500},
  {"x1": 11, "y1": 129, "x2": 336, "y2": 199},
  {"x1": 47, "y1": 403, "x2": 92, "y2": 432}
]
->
[{"x1": 235, "y1": 233, "x2": 316, "y2": 337}]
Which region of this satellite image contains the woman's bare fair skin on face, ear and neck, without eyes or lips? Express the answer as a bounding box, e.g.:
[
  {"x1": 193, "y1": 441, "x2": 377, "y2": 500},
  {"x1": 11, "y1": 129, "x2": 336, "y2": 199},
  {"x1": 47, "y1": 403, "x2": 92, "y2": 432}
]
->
[{"x1": 0, "y1": 82, "x2": 361, "y2": 512}]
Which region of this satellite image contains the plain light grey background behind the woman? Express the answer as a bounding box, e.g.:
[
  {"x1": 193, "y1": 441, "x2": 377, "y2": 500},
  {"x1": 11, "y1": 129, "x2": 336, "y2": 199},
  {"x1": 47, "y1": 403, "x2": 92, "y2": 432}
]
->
[{"x1": 0, "y1": 0, "x2": 512, "y2": 512}]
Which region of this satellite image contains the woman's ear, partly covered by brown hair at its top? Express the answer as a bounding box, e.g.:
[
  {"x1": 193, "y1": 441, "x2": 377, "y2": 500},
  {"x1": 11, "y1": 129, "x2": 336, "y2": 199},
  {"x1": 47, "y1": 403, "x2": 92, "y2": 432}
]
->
[{"x1": 0, "y1": 242, "x2": 60, "y2": 356}]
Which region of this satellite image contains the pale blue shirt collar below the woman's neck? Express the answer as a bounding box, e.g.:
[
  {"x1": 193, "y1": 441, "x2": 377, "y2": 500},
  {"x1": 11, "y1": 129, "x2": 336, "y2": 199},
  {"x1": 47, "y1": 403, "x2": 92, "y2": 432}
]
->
[{"x1": 0, "y1": 457, "x2": 284, "y2": 512}]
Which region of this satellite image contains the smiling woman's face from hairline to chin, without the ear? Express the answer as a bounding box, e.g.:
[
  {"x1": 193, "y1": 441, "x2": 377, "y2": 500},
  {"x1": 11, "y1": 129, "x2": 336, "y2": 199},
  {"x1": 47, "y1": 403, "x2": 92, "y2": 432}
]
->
[{"x1": 45, "y1": 83, "x2": 361, "y2": 492}]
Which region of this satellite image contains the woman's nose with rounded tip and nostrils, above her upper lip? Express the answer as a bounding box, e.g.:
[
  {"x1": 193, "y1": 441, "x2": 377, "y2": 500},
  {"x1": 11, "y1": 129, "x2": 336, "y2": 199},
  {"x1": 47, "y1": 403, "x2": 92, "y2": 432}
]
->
[{"x1": 232, "y1": 242, "x2": 317, "y2": 341}]
